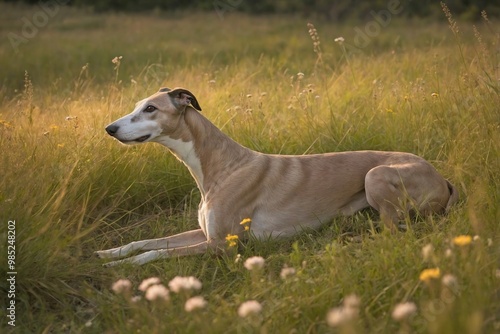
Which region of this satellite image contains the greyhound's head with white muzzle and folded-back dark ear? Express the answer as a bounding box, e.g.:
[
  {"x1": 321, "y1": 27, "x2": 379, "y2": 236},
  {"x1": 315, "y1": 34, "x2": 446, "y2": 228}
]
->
[{"x1": 106, "y1": 88, "x2": 201, "y2": 144}]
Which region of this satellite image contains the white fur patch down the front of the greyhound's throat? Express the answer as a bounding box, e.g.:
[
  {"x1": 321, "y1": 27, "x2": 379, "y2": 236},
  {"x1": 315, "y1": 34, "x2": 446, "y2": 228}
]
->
[{"x1": 154, "y1": 136, "x2": 205, "y2": 194}]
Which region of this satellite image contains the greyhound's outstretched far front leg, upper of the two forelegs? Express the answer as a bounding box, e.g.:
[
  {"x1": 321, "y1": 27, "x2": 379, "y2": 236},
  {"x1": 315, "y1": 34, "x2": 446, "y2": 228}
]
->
[{"x1": 96, "y1": 229, "x2": 207, "y2": 259}]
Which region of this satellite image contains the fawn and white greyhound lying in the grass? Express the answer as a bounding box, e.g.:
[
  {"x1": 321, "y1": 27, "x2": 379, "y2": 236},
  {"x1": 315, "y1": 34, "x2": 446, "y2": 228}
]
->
[{"x1": 96, "y1": 88, "x2": 458, "y2": 266}]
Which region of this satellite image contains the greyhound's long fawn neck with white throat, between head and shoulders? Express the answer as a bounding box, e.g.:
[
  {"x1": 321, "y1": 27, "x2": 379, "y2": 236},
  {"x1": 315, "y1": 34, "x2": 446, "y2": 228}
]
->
[{"x1": 158, "y1": 107, "x2": 255, "y2": 197}]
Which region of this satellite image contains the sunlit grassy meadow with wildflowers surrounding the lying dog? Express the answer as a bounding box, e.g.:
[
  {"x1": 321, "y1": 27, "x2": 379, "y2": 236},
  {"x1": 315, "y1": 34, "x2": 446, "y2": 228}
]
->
[{"x1": 0, "y1": 3, "x2": 500, "y2": 333}]
